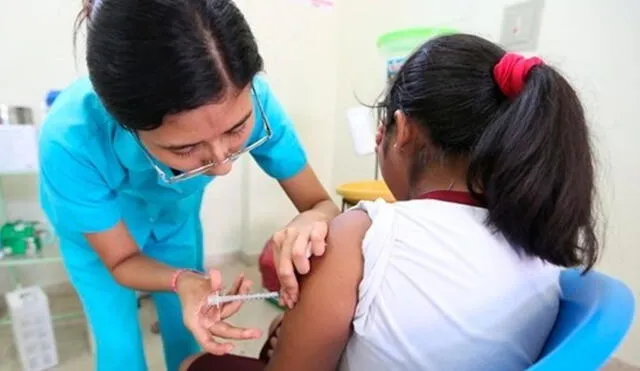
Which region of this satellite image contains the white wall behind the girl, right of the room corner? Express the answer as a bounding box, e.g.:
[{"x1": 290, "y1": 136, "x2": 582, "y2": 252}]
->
[{"x1": 333, "y1": 0, "x2": 640, "y2": 366}]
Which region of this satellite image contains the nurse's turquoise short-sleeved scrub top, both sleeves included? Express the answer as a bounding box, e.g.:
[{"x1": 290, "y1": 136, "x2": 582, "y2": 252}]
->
[{"x1": 39, "y1": 77, "x2": 307, "y2": 263}]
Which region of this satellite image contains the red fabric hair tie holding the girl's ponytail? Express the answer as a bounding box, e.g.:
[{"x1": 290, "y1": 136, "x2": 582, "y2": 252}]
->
[{"x1": 493, "y1": 53, "x2": 544, "y2": 99}]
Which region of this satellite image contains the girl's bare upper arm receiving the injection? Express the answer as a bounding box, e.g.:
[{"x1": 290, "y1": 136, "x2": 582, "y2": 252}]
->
[{"x1": 267, "y1": 210, "x2": 371, "y2": 371}]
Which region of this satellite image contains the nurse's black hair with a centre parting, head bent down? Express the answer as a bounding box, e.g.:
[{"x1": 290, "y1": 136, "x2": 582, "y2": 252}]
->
[{"x1": 75, "y1": 0, "x2": 263, "y2": 130}]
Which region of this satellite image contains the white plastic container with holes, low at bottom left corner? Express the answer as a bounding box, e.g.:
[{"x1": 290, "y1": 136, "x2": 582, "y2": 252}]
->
[{"x1": 5, "y1": 286, "x2": 58, "y2": 371}]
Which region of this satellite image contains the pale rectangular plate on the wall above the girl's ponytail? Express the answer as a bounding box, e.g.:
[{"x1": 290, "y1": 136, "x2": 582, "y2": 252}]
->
[{"x1": 500, "y1": 0, "x2": 544, "y2": 52}]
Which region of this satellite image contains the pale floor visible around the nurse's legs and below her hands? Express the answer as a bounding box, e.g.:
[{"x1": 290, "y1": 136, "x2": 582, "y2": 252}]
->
[{"x1": 0, "y1": 263, "x2": 640, "y2": 371}]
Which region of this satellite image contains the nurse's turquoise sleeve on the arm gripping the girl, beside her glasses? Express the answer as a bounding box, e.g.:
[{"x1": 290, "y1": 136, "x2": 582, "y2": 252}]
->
[{"x1": 252, "y1": 79, "x2": 307, "y2": 180}]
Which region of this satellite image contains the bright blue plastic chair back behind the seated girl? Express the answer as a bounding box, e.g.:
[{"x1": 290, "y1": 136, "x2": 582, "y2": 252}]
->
[{"x1": 529, "y1": 269, "x2": 634, "y2": 371}]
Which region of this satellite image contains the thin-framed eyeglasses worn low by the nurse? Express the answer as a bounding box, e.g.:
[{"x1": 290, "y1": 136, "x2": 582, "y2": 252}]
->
[{"x1": 133, "y1": 86, "x2": 272, "y2": 184}]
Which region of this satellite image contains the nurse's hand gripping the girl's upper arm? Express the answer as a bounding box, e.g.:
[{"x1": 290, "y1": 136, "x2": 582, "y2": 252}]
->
[{"x1": 269, "y1": 218, "x2": 328, "y2": 308}]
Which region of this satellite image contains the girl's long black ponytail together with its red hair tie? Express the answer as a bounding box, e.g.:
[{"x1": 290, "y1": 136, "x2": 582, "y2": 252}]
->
[{"x1": 467, "y1": 54, "x2": 599, "y2": 271}]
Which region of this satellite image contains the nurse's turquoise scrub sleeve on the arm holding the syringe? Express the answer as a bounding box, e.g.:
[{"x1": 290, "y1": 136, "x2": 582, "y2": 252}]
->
[{"x1": 40, "y1": 141, "x2": 121, "y2": 233}]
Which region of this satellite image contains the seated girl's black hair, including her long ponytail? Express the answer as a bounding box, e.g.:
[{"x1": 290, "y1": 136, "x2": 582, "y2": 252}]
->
[{"x1": 378, "y1": 34, "x2": 600, "y2": 271}]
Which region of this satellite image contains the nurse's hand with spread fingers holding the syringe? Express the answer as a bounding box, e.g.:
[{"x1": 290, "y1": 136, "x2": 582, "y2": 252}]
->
[{"x1": 177, "y1": 269, "x2": 261, "y2": 355}]
